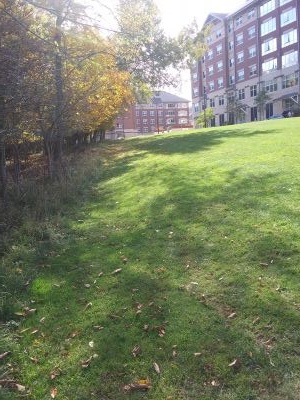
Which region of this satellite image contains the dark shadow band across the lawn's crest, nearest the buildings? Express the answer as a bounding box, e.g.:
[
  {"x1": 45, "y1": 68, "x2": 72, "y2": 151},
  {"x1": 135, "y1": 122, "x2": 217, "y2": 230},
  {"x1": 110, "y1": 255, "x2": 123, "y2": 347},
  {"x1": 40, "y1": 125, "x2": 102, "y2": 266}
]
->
[{"x1": 134, "y1": 128, "x2": 278, "y2": 154}]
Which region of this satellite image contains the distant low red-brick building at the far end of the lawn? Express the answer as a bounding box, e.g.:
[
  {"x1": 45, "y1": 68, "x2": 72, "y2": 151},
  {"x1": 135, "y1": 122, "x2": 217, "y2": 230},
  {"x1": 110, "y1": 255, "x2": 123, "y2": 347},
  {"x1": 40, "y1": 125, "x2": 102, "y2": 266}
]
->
[{"x1": 109, "y1": 91, "x2": 193, "y2": 138}]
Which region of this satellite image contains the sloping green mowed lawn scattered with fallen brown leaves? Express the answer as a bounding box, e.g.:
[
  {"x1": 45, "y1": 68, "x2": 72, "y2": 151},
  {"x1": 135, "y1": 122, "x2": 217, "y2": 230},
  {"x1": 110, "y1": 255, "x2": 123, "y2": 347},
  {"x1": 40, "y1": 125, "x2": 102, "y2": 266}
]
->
[{"x1": 0, "y1": 118, "x2": 300, "y2": 400}]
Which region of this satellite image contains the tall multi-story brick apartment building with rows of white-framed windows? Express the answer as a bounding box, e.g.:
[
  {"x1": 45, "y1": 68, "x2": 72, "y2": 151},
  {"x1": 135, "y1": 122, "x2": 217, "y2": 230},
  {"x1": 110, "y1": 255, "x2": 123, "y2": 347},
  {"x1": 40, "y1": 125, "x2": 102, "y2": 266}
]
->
[{"x1": 191, "y1": 0, "x2": 300, "y2": 126}]
